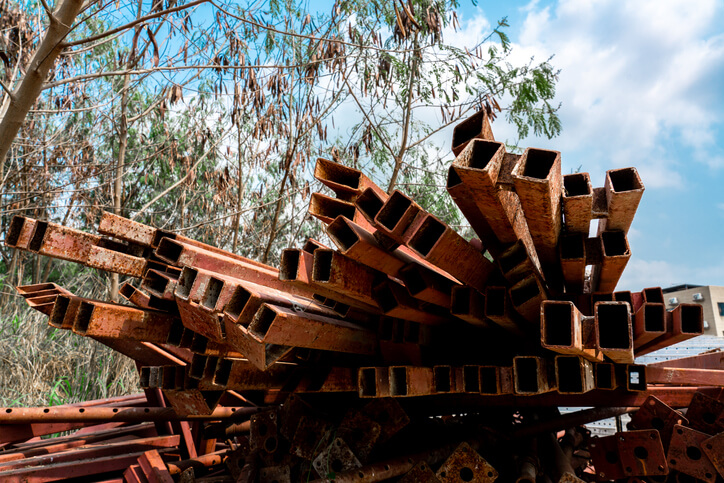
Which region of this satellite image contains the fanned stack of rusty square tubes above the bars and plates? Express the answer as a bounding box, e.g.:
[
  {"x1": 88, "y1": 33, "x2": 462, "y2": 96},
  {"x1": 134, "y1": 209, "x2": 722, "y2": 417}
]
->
[{"x1": 6, "y1": 113, "x2": 724, "y2": 481}]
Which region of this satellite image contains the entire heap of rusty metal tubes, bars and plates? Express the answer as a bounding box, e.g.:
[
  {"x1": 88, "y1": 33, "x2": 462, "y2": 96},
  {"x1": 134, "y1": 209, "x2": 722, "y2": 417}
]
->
[{"x1": 0, "y1": 112, "x2": 724, "y2": 482}]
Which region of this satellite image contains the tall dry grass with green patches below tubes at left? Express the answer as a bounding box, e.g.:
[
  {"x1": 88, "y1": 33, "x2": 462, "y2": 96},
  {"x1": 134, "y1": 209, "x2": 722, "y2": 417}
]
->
[{"x1": 0, "y1": 266, "x2": 140, "y2": 406}]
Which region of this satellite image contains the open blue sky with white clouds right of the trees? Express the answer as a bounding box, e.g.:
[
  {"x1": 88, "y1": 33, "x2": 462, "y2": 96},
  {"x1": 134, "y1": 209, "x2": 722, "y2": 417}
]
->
[{"x1": 396, "y1": 0, "x2": 724, "y2": 291}]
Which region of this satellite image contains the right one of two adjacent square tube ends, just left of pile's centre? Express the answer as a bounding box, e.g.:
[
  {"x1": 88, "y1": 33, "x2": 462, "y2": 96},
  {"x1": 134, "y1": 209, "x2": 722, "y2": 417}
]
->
[{"x1": 312, "y1": 249, "x2": 384, "y2": 307}]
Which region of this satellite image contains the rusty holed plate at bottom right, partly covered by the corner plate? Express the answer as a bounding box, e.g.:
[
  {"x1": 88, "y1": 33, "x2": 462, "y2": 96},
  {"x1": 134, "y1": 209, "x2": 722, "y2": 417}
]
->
[{"x1": 666, "y1": 424, "x2": 717, "y2": 483}]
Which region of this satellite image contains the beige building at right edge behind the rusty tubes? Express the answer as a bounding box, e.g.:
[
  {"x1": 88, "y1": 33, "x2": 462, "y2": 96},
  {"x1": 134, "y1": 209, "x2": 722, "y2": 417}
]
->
[{"x1": 664, "y1": 285, "x2": 724, "y2": 337}]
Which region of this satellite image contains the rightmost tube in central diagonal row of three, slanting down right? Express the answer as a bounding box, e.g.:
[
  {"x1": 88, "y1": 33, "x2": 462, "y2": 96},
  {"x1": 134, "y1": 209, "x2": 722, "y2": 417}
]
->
[{"x1": 408, "y1": 214, "x2": 495, "y2": 291}]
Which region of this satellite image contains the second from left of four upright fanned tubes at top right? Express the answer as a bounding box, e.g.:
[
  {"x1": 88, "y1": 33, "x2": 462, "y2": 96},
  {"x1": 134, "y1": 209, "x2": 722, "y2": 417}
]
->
[{"x1": 513, "y1": 148, "x2": 563, "y2": 285}]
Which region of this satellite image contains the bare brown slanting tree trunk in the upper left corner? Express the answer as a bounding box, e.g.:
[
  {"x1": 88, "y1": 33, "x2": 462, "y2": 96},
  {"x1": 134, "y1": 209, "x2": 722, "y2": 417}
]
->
[{"x1": 0, "y1": 0, "x2": 83, "y2": 190}]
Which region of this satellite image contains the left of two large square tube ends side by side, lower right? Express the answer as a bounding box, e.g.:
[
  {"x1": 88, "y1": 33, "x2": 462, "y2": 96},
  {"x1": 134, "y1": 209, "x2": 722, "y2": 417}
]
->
[{"x1": 540, "y1": 300, "x2": 603, "y2": 362}]
